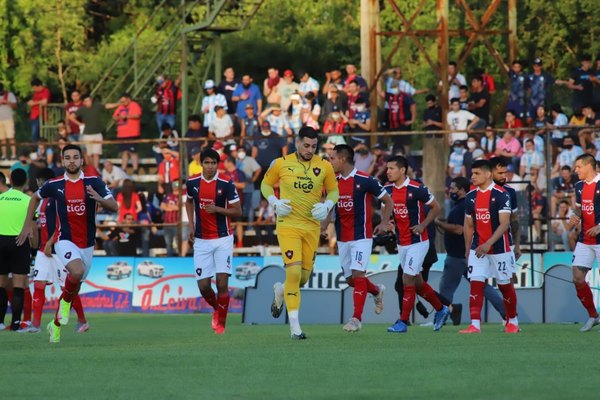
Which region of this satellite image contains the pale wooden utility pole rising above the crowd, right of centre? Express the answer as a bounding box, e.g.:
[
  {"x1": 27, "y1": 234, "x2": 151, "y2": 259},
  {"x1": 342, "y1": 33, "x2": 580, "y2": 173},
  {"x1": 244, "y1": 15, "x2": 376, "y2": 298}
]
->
[{"x1": 360, "y1": 0, "x2": 381, "y2": 139}]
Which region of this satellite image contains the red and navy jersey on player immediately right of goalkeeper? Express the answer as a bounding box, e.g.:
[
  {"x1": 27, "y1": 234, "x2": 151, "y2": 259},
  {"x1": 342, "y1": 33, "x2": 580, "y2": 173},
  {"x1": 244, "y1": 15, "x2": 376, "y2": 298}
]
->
[{"x1": 335, "y1": 169, "x2": 387, "y2": 242}]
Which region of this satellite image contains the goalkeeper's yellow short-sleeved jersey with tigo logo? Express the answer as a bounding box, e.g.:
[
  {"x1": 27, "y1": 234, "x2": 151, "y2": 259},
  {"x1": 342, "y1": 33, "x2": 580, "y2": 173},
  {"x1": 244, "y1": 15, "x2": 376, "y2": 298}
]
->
[{"x1": 264, "y1": 153, "x2": 338, "y2": 229}]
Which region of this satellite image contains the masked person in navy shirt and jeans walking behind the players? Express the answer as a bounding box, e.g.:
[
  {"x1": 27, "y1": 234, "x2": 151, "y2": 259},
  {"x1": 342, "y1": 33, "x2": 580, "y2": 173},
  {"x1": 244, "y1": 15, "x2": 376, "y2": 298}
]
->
[{"x1": 435, "y1": 176, "x2": 505, "y2": 325}]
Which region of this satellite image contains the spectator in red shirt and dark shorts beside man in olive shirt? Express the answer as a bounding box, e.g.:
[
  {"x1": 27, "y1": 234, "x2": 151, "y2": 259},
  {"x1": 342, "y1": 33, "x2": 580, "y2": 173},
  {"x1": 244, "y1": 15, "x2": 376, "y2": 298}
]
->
[{"x1": 113, "y1": 93, "x2": 142, "y2": 174}]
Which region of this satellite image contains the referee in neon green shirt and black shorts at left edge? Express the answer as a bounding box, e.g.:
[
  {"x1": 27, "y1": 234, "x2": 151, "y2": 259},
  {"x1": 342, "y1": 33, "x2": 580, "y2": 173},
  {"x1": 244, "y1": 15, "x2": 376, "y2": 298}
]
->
[{"x1": 0, "y1": 168, "x2": 31, "y2": 331}]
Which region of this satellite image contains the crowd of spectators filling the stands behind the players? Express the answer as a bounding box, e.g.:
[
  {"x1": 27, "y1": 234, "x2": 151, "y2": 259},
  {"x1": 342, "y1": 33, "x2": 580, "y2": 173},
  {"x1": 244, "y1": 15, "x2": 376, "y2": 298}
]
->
[{"x1": 0, "y1": 56, "x2": 600, "y2": 255}]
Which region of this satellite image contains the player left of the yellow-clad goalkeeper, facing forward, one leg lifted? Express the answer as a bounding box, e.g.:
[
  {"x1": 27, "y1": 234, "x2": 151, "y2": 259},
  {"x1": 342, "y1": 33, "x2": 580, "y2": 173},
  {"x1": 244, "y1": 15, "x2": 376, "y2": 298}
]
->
[{"x1": 185, "y1": 149, "x2": 242, "y2": 335}]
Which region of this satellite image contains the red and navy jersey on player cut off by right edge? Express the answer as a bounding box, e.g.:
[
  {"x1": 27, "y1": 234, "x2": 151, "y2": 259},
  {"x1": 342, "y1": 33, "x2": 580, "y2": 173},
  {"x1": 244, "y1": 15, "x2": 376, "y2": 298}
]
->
[{"x1": 575, "y1": 174, "x2": 600, "y2": 245}]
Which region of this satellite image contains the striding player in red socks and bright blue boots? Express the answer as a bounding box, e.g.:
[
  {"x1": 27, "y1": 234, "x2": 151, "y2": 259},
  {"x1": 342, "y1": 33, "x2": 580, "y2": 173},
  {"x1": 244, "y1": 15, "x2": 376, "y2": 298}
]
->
[{"x1": 385, "y1": 156, "x2": 450, "y2": 333}]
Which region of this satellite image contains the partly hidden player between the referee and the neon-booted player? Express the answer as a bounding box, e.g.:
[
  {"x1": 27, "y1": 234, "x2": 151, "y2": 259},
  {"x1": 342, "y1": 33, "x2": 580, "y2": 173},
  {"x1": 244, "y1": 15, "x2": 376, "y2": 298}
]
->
[{"x1": 21, "y1": 168, "x2": 89, "y2": 333}]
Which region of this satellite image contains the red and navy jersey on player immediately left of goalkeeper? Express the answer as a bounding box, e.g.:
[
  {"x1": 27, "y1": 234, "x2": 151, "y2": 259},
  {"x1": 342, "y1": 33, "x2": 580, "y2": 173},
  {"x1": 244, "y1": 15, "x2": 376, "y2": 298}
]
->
[{"x1": 187, "y1": 174, "x2": 240, "y2": 239}]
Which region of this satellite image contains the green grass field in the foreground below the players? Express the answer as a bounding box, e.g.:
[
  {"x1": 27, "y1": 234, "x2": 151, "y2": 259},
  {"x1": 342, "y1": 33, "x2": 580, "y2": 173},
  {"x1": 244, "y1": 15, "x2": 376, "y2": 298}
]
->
[{"x1": 0, "y1": 314, "x2": 600, "y2": 399}]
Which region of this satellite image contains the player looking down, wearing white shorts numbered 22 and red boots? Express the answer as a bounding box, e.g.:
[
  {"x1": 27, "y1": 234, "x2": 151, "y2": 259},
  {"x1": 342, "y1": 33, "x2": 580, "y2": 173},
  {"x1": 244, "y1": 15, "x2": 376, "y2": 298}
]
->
[{"x1": 459, "y1": 160, "x2": 519, "y2": 333}]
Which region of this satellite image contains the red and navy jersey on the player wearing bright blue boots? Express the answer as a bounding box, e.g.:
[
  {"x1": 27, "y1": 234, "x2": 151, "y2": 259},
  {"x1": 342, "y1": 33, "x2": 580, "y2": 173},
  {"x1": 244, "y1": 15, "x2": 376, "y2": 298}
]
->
[{"x1": 385, "y1": 178, "x2": 435, "y2": 246}]
